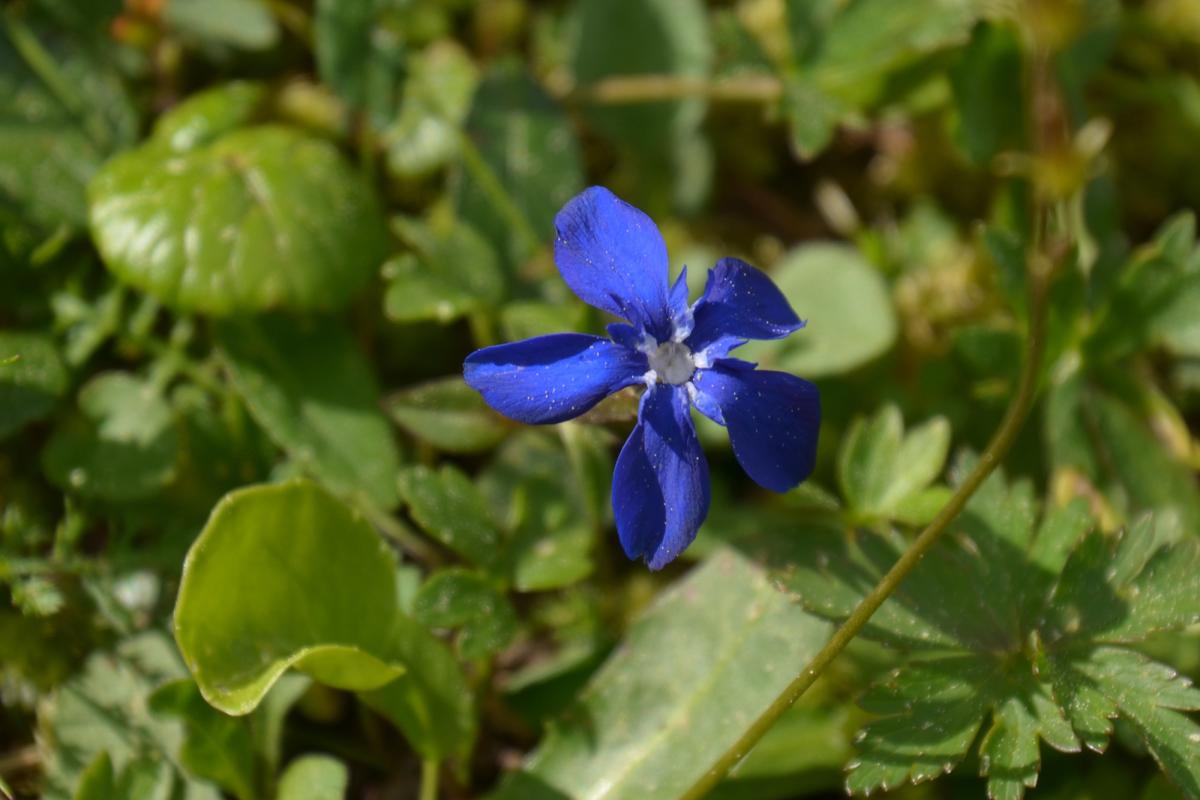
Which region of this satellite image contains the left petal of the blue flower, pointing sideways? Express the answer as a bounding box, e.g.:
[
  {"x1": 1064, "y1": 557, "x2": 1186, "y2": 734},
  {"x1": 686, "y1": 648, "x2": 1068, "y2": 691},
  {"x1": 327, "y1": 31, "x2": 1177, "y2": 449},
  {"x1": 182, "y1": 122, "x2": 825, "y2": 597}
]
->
[{"x1": 463, "y1": 333, "x2": 649, "y2": 425}]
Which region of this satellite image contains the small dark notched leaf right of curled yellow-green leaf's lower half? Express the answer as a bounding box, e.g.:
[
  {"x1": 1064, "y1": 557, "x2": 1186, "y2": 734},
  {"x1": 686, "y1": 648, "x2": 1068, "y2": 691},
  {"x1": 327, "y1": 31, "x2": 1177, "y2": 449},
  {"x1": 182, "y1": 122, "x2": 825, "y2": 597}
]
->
[{"x1": 413, "y1": 567, "x2": 517, "y2": 658}]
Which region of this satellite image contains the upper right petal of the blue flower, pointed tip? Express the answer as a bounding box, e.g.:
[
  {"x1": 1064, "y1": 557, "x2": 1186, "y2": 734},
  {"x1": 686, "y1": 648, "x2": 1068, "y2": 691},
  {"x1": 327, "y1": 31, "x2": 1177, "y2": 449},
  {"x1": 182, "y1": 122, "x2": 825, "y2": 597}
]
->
[{"x1": 688, "y1": 258, "x2": 804, "y2": 361}]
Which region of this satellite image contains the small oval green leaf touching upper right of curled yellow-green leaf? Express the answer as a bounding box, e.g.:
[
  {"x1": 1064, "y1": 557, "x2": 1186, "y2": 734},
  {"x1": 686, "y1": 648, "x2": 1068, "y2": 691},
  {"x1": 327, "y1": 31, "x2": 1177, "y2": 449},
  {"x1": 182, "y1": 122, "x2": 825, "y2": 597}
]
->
[{"x1": 400, "y1": 465, "x2": 503, "y2": 573}]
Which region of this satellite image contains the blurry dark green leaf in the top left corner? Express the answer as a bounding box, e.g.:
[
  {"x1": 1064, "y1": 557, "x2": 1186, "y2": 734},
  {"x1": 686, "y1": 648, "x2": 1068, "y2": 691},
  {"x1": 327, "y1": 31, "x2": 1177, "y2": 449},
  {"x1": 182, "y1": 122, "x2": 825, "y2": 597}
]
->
[{"x1": 0, "y1": 9, "x2": 138, "y2": 229}]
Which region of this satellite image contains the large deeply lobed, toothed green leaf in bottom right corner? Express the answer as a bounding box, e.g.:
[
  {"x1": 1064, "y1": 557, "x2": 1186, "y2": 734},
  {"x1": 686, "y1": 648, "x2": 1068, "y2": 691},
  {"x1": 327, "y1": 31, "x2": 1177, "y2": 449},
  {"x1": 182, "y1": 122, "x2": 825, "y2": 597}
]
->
[{"x1": 763, "y1": 463, "x2": 1200, "y2": 800}]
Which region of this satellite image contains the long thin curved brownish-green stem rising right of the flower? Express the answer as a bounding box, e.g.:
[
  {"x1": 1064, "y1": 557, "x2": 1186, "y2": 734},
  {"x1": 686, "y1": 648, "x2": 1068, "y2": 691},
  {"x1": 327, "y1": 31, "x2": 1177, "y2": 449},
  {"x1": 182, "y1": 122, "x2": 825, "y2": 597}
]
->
[{"x1": 680, "y1": 252, "x2": 1052, "y2": 800}]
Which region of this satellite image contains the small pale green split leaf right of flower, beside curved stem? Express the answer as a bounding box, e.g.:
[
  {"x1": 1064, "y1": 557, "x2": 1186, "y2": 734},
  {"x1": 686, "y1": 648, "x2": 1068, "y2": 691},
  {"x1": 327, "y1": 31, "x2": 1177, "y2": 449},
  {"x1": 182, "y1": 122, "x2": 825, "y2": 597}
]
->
[{"x1": 838, "y1": 405, "x2": 950, "y2": 518}]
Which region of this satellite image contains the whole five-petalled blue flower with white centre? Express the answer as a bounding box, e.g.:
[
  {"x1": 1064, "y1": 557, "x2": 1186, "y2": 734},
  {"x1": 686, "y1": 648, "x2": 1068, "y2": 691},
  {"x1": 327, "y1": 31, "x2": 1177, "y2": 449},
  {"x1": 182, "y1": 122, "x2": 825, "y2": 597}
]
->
[{"x1": 463, "y1": 186, "x2": 821, "y2": 570}]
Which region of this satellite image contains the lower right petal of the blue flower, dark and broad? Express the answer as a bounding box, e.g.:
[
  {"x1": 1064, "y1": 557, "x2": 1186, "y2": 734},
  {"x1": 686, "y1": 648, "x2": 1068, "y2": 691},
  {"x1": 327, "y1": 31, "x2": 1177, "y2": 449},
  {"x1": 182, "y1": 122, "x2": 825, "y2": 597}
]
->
[{"x1": 694, "y1": 360, "x2": 821, "y2": 492}]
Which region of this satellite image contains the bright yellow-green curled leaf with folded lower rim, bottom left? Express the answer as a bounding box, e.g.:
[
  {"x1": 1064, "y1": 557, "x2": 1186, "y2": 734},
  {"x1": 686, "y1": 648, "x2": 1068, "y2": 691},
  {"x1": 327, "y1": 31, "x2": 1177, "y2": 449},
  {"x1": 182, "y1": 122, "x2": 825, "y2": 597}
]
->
[{"x1": 175, "y1": 482, "x2": 473, "y2": 758}]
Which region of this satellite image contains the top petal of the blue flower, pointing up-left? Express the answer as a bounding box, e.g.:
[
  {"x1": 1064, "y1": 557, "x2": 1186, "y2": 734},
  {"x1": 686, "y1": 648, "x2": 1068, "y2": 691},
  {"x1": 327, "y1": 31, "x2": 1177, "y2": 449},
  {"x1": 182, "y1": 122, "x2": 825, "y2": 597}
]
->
[{"x1": 554, "y1": 186, "x2": 671, "y2": 341}]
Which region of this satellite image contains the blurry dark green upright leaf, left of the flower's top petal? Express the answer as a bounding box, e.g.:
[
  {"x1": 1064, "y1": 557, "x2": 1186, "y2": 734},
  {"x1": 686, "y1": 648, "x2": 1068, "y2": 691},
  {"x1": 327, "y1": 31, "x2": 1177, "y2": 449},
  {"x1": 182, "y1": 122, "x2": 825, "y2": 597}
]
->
[{"x1": 455, "y1": 62, "x2": 583, "y2": 267}]
